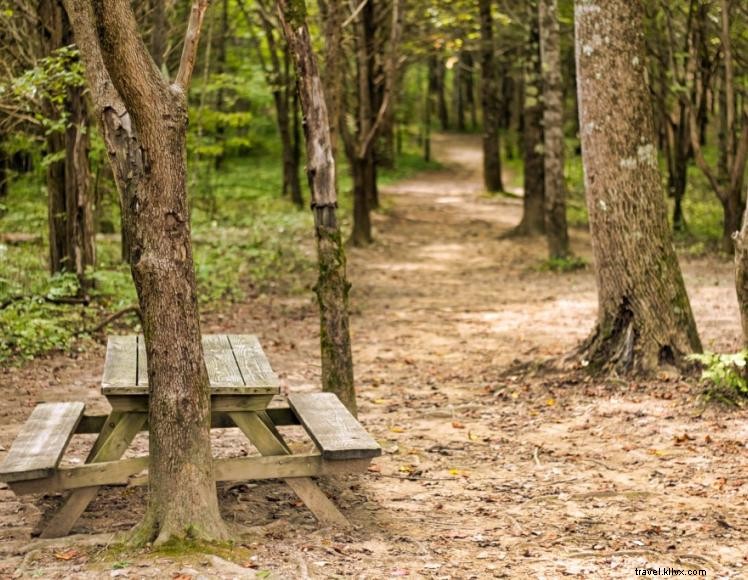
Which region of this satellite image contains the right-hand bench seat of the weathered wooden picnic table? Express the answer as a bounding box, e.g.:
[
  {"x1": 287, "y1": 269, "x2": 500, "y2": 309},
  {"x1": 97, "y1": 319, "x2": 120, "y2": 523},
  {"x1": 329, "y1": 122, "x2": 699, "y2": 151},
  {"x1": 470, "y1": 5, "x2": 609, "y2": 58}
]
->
[{"x1": 288, "y1": 393, "x2": 382, "y2": 459}]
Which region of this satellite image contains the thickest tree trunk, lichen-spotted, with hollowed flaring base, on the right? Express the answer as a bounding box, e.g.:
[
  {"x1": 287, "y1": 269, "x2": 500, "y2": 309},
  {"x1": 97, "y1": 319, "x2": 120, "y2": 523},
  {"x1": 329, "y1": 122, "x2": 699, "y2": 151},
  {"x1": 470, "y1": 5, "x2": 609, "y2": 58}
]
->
[{"x1": 575, "y1": 0, "x2": 701, "y2": 373}]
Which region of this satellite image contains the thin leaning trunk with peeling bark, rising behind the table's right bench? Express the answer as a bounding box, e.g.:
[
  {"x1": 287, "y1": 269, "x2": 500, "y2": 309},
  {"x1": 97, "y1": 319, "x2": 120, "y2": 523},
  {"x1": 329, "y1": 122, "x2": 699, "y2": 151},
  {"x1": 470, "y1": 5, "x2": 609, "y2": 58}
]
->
[{"x1": 278, "y1": 0, "x2": 356, "y2": 415}]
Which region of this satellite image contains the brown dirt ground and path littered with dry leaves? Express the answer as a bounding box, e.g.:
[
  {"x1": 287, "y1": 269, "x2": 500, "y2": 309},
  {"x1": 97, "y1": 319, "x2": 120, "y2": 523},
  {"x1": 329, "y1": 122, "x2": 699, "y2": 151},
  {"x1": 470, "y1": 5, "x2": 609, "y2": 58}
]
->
[{"x1": 0, "y1": 135, "x2": 748, "y2": 578}]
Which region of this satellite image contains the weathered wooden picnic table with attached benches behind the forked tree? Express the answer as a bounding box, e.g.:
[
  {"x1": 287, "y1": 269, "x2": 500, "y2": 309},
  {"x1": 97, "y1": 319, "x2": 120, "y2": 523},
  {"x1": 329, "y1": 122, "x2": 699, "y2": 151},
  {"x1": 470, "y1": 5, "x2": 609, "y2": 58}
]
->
[{"x1": 0, "y1": 334, "x2": 381, "y2": 538}]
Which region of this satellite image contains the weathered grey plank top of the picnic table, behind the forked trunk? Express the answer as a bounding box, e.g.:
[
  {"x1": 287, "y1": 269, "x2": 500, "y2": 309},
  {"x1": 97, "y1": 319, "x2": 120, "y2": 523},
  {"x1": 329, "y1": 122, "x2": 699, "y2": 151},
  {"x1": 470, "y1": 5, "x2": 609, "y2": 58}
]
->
[{"x1": 101, "y1": 334, "x2": 280, "y2": 397}]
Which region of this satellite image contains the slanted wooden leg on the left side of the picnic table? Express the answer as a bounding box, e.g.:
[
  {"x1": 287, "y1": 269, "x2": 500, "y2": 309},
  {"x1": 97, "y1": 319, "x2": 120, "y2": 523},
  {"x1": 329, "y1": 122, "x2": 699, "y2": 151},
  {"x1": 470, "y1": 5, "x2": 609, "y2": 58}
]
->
[{"x1": 41, "y1": 412, "x2": 148, "y2": 538}]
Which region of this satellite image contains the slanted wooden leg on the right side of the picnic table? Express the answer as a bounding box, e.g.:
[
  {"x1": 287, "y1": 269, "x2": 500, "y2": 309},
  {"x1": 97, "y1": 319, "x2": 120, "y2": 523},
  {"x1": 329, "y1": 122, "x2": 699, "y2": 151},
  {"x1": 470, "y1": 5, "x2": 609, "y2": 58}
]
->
[{"x1": 229, "y1": 411, "x2": 351, "y2": 528}]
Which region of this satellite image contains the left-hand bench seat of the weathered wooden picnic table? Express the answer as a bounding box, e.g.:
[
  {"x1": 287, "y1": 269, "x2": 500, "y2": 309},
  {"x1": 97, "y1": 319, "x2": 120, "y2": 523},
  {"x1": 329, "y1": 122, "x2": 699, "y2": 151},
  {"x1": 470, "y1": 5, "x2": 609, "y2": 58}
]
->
[{"x1": 0, "y1": 403, "x2": 86, "y2": 482}]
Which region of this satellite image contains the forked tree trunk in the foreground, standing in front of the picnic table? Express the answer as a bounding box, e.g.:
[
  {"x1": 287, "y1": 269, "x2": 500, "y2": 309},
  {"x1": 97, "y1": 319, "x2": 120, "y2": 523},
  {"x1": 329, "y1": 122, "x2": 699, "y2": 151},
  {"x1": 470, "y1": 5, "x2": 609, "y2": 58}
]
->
[{"x1": 71, "y1": 0, "x2": 227, "y2": 544}]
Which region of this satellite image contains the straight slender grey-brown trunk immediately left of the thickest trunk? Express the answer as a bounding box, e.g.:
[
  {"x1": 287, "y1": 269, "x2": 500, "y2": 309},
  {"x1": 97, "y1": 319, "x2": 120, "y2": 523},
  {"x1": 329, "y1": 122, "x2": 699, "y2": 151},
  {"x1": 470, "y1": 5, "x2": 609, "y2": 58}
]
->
[{"x1": 538, "y1": 0, "x2": 570, "y2": 259}]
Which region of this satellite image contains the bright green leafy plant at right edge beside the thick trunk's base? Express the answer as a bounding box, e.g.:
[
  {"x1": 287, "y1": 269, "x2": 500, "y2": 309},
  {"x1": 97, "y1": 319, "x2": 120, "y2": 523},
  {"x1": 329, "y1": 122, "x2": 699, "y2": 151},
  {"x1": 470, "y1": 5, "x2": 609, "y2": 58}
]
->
[{"x1": 688, "y1": 350, "x2": 748, "y2": 406}]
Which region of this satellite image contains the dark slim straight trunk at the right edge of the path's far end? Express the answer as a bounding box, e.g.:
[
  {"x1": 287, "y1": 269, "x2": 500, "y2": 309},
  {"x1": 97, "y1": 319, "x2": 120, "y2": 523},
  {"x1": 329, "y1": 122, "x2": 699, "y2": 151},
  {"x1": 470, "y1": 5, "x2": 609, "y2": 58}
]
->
[{"x1": 478, "y1": 0, "x2": 504, "y2": 192}]
